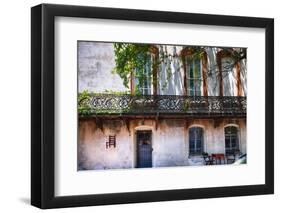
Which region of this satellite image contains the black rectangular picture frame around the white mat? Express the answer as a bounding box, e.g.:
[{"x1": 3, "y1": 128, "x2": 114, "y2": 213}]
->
[{"x1": 31, "y1": 4, "x2": 274, "y2": 209}]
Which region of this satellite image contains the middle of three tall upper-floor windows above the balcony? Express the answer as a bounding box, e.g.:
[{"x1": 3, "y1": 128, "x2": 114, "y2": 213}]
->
[{"x1": 186, "y1": 58, "x2": 203, "y2": 96}]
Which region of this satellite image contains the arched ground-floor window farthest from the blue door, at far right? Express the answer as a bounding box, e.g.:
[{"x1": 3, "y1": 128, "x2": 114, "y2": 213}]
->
[{"x1": 224, "y1": 126, "x2": 239, "y2": 155}]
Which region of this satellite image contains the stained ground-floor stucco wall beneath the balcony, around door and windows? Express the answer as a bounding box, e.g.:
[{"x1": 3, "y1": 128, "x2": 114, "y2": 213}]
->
[{"x1": 78, "y1": 119, "x2": 246, "y2": 170}]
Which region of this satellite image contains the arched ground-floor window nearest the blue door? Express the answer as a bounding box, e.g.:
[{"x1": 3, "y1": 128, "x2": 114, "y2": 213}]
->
[{"x1": 189, "y1": 127, "x2": 203, "y2": 155}]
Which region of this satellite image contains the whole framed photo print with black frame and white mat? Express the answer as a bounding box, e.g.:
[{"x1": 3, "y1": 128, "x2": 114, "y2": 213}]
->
[{"x1": 31, "y1": 4, "x2": 274, "y2": 208}]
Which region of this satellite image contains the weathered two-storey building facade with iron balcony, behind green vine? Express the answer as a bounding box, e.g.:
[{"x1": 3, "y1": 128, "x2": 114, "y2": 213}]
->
[{"x1": 78, "y1": 41, "x2": 247, "y2": 170}]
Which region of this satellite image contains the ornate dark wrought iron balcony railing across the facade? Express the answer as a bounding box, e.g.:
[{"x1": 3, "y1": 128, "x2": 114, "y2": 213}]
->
[{"x1": 79, "y1": 94, "x2": 247, "y2": 117}]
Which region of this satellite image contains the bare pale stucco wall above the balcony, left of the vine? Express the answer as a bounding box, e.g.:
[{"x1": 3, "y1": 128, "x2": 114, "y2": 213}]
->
[{"x1": 78, "y1": 41, "x2": 128, "y2": 92}]
